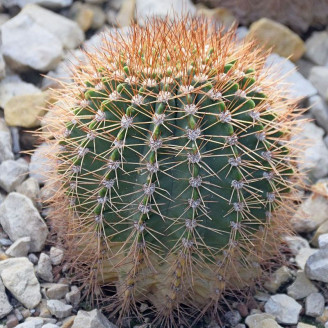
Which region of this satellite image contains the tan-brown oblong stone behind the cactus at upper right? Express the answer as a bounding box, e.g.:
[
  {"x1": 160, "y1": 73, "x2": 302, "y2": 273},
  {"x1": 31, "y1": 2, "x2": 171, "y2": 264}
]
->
[{"x1": 249, "y1": 18, "x2": 305, "y2": 61}]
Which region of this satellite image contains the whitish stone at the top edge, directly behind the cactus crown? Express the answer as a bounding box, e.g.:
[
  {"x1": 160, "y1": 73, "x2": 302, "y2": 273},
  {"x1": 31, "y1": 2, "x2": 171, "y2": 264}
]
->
[{"x1": 136, "y1": 0, "x2": 196, "y2": 26}]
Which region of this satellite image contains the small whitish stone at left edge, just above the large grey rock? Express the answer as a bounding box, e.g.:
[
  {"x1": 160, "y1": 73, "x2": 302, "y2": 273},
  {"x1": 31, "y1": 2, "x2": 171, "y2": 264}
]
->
[{"x1": 0, "y1": 158, "x2": 28, "y2": 192}]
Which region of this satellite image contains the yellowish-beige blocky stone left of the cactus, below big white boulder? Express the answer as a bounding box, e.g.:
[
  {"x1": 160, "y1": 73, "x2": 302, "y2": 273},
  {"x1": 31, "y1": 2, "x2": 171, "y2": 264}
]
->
[{"x1": 4, "y1": 93, "x2": 48, "y2": 128}]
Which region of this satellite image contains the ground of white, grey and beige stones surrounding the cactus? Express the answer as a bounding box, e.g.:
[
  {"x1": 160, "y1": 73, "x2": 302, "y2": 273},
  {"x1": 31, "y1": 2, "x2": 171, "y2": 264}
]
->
[{"x1": 0, "y1": 0, "x2": 328, "y2": 328}]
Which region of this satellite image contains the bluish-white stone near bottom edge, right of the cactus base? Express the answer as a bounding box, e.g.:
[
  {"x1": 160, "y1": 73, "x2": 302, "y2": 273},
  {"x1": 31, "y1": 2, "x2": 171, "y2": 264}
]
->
[{"x1": 264, "y1": 294, "x2": 302, "y2": 325}]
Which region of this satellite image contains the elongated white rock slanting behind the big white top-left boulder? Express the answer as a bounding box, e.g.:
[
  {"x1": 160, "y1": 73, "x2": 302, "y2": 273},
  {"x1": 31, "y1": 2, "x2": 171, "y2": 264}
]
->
[{"x1": 19, "y1": 4, "x2": 84, "y2": 49}]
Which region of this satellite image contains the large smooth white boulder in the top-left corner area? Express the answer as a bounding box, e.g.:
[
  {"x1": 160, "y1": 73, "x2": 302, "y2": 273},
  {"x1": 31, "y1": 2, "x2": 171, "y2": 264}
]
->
[{"x1": 1, "y1": 14, "x2": 63, "y2": 72}]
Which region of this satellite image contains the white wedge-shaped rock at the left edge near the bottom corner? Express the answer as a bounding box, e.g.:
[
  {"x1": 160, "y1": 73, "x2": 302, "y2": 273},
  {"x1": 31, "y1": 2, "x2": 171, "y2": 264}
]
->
[{"x1": 0, "y1": 257, "x2": 41, "y2": 309}]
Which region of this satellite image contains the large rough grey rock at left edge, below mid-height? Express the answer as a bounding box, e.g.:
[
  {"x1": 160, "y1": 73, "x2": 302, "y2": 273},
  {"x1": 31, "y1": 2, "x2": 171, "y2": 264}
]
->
[{"x1": 0, "y1": 192, "x2": 48, "y2": 252}]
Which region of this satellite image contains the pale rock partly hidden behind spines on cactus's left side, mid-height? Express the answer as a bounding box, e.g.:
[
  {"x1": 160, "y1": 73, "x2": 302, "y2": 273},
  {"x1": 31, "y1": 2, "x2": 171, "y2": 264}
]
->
[{"x1": 30, "y1": 143, "x2": 52, "y2": 184}]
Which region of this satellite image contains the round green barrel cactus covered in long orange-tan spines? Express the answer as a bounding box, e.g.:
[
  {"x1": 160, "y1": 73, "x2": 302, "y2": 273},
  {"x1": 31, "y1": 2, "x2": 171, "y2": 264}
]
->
[{"x1": 44, "y1": 18, "x2": 300, "y2": 327}]
